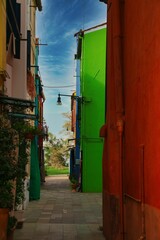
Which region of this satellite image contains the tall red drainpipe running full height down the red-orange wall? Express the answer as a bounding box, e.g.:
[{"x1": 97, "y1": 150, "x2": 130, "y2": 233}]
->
[{"x1": 112, "y1": 0, "x2": 124, "y2": 240}]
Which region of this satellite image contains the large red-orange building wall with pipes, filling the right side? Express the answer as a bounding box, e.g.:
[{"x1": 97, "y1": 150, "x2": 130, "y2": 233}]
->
[{"x1": 101, "y1": 0, "x2": 160, "y2": 240}]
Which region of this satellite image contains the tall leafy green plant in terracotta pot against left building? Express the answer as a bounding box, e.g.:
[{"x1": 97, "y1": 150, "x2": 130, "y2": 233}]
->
[{"x1": 0, "y1": 115, "x2": 30, "y2": 237}]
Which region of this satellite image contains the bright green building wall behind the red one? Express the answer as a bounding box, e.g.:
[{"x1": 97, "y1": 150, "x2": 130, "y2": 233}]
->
[{"x1": 81, "y1": 28, "x2": 106, "y2": 192}]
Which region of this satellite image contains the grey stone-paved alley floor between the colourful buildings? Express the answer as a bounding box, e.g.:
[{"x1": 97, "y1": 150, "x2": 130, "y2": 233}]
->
[{"x1": 14, "y1": 175, "x2": 105, "y2": 240}]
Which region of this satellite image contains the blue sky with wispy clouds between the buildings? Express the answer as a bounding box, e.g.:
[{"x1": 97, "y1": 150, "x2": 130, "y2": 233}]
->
[{"x1": 36, "y1": 0, "x2": 106, "y2": 137}]
